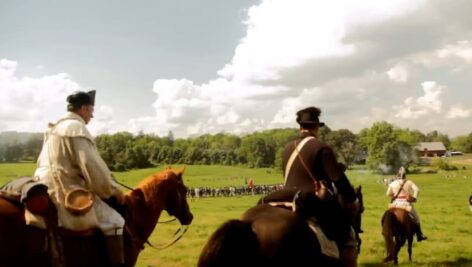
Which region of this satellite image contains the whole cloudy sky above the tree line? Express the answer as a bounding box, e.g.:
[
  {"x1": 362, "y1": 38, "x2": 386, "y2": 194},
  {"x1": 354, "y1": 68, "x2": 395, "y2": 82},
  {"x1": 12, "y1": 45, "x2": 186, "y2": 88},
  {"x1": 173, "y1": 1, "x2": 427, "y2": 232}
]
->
[{"x1": 0, "y1": 0, "x2": 472, "y2": 138}]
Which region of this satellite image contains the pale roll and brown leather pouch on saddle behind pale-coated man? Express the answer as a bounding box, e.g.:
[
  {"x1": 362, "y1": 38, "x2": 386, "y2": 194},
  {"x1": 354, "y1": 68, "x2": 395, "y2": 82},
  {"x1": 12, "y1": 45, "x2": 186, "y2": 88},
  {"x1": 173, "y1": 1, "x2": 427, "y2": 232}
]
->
[{"x1": 0, "y1": 177, "x2": 49, "y2": 229}]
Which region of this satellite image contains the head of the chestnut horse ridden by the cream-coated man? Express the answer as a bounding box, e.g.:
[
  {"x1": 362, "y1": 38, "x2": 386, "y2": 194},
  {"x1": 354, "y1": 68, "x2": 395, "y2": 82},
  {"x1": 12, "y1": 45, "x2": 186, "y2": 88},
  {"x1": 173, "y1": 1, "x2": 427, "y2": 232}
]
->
[{"x1": 163, "y1": 168, "x2": 193, "y2": 225}]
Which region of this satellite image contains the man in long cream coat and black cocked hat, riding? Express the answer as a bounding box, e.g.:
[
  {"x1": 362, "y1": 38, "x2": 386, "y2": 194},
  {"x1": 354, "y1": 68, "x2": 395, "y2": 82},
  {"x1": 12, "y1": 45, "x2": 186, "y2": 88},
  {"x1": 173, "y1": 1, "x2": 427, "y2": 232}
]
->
[{"x1": 35, "y1": 91, "x2": 125, "y2": 266}]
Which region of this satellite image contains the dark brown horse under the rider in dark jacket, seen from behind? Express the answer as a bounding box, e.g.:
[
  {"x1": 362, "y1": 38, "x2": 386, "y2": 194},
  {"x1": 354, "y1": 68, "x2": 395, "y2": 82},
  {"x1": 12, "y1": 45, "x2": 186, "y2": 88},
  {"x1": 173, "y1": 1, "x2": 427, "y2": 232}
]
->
[{"x1": 197, "y1": 188, "x2": 363, "y2": 267}]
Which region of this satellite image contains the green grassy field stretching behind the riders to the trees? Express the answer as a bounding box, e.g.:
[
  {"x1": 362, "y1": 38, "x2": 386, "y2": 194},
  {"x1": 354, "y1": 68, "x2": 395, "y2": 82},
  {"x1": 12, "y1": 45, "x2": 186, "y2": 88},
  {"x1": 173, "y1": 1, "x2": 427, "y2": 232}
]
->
[{"x1": 0, "y1": 161, "x2": 472, "y2": 267}]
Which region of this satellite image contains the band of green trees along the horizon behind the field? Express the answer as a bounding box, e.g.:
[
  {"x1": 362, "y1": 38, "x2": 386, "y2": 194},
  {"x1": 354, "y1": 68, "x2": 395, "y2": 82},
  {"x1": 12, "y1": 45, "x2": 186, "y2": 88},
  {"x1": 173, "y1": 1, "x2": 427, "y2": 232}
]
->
[{"x1": 0, "y1": 122, "x2": 472, "y2": 171}]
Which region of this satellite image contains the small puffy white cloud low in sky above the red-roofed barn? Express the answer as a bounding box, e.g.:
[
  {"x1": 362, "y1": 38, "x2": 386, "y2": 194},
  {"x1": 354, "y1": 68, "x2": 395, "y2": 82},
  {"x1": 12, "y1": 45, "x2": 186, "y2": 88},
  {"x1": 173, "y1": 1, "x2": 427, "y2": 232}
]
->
[{"x1": 394, "y1": 81, "x2": 445, "y2": 119}]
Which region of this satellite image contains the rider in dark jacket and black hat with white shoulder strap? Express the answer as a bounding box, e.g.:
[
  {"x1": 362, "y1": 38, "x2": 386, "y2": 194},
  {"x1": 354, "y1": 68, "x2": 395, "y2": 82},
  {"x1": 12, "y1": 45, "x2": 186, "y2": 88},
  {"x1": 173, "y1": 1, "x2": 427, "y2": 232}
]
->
[{"x1": 282, "y1": 107, "x2": 358, "y2": 266}]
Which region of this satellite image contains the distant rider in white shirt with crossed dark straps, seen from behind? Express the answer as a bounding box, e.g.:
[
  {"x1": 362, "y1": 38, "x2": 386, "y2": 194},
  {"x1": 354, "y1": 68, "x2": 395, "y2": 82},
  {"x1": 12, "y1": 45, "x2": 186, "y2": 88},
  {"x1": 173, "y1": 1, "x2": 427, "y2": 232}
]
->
[{"x1": 387, "y1": 167, "x2": 427, "y2": 242}]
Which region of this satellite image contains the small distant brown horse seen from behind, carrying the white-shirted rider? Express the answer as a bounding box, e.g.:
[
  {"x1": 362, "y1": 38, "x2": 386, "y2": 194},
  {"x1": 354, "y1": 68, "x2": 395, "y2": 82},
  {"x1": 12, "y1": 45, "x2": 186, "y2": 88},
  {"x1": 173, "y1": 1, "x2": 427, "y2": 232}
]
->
[{"x1": 381, "y1": 208, "x2": 417, "y2": 265}]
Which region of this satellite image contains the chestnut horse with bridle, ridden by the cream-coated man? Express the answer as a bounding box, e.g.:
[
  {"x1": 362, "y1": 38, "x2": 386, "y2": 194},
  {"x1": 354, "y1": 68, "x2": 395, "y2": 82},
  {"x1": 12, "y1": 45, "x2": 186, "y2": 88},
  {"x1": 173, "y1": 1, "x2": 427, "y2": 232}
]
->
[{"x1": 0, "y1": 169, "x2": 193, "y2": 267}]
